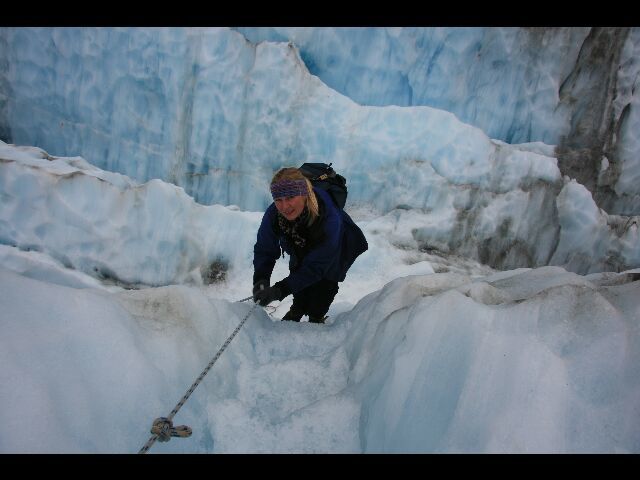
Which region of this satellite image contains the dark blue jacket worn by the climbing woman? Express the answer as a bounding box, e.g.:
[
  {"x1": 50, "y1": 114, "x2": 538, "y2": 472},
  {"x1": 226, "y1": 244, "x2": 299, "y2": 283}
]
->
[{"x1": 253, "y1": 187, "x2": 369, "y2": 296}]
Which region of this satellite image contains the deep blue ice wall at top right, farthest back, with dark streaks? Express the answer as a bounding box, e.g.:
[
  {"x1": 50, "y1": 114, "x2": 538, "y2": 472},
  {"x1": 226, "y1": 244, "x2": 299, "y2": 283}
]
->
[{"x1": 236, "y1": 27, "x2": 640, "y2": 215}]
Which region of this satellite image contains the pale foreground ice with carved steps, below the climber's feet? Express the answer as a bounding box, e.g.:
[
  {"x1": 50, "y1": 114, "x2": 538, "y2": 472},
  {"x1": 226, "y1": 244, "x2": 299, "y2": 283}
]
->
[{"x1": 0, "y1": 256, "x2": 640, "y2": 453}]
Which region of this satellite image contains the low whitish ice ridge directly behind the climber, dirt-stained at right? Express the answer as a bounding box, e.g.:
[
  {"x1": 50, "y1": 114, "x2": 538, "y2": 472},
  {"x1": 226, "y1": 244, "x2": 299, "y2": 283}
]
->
[{"x1": 0, "y1": 137, "x2": 640, "y2": 286}]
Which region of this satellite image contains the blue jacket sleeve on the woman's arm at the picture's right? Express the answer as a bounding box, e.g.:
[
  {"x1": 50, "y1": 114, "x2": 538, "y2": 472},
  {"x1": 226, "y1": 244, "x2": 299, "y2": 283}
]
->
[{"x1": 283, "y1": 202, "x2": 343, "y2": 293}]
